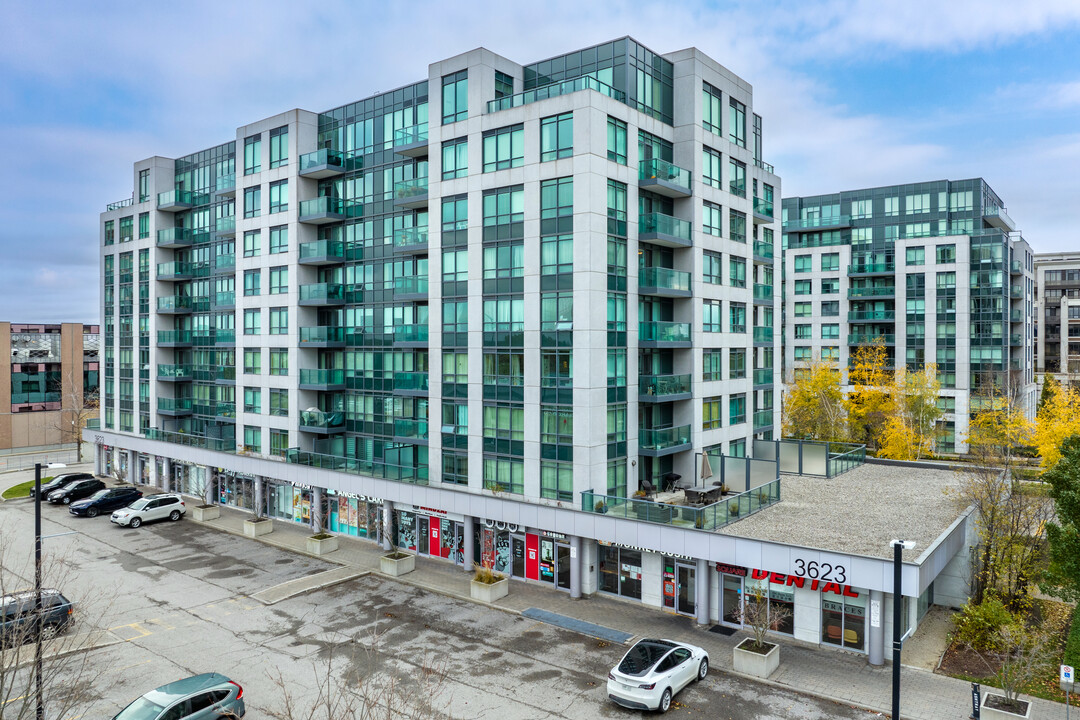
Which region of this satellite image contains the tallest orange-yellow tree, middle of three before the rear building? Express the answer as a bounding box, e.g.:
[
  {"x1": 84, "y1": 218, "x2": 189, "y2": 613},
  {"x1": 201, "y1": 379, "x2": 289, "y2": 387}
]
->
[{"x1": 845, "y1": 337, "x2": 893, "y2": 448}]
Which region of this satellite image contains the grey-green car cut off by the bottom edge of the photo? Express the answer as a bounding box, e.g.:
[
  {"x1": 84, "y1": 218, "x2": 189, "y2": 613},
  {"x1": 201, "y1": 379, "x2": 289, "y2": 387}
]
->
[{"x1": 112, "y1": 673, "x2": 244, "y2": 720}]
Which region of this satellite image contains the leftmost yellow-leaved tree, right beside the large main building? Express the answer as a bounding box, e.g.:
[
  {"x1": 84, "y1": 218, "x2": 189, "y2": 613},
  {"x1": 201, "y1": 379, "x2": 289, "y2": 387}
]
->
[{"x1": 784, "y1": 361, "x2": 847, "y2": 440}]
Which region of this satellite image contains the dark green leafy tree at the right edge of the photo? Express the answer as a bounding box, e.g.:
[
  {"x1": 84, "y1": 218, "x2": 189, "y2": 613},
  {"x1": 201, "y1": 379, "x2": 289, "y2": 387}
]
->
[{"x1": 1041, "y1": 435, "x2": 1080, "y2": 602}]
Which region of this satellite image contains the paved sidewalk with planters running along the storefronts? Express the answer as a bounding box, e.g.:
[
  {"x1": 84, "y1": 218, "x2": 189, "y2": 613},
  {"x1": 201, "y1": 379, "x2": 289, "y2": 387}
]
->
[{"x1": 181, "y1": 500, "x2": 1067, "y2": 720}]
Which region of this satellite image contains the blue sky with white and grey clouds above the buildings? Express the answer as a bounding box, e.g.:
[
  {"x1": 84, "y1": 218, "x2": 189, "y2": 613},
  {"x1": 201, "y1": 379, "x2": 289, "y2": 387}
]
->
[{"x1": 0, "y1": 0, "x2": 1080, "y2": 323}]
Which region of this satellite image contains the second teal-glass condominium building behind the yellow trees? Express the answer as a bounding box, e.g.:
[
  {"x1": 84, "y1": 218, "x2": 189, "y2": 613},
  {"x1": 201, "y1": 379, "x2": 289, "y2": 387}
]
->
[{"x1": 783, "y1": 178, "x2": 1037, "y2": 452}]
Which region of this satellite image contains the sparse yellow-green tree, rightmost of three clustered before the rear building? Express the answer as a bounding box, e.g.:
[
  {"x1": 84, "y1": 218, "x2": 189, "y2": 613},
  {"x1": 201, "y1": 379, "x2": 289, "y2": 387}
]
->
[{"x1": 878, "y1": 364, "x2": 942, "y2": 460}]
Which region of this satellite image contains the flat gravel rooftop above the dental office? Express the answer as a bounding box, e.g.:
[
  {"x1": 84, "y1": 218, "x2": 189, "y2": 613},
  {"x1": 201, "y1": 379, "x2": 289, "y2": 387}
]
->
[{"x1": 719, "y1": 464, "x2": 963, "y2": 561}]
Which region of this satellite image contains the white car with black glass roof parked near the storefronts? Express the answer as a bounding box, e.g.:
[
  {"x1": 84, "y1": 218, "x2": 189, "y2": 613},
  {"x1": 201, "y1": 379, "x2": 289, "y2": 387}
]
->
[{"x1": 608, "y1": 639, "x2": 708, "y2": 712}]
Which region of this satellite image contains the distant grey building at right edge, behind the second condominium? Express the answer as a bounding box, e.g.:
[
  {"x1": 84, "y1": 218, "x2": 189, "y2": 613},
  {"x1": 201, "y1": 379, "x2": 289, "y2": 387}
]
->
[{"x1": 1035, "y1": 253, "x2": 1080, "y2": 384}]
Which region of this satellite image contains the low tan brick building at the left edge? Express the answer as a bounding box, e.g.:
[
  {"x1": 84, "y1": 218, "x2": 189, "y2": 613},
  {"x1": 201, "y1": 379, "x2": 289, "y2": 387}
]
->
[{"x1": 0, "y1": 322, "x2": 99, "y2": 453}]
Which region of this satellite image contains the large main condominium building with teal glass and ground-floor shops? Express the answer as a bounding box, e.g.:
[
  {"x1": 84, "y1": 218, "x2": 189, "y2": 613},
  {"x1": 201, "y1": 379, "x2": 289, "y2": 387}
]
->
[{"x1": 87, "y1": 38, "x2": 976, "y2": 662}]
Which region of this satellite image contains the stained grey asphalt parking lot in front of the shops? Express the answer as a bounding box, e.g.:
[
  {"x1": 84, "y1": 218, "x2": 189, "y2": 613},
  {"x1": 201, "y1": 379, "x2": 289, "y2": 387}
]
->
[{"x1": 0, "y1": 481, "x2": 867, "y2": 720}]
